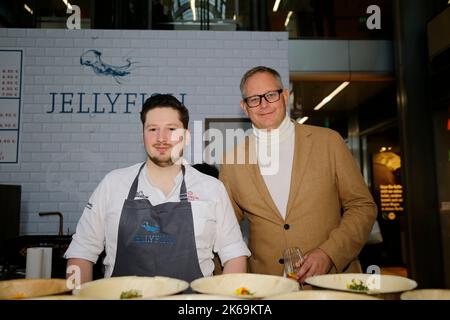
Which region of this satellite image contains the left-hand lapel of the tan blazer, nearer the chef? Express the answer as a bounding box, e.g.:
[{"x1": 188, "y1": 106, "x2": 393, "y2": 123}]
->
[{"x1": 245, "y1": 135, "x2": 282, "y2": 219}]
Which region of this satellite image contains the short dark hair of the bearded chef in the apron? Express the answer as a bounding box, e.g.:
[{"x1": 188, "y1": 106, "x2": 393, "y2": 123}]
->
[{"x1": 141, "y1": 94, "x2": 189, "y2": 129}]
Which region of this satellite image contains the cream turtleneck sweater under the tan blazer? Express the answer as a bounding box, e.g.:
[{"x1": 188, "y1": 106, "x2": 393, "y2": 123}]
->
[{"x1": 253, "y1": 115, "x2": 295, "y2": 219}]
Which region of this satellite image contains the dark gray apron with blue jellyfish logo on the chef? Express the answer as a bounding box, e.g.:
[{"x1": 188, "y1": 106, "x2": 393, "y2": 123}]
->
[{"x1": 112, "y1": 162, "x2": 203, "y2": 282}]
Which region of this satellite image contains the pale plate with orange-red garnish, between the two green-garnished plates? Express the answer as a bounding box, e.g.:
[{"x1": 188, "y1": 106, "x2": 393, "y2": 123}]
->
[{"x1": 191, "y1": 273, "x2": 299, "y2": 299}]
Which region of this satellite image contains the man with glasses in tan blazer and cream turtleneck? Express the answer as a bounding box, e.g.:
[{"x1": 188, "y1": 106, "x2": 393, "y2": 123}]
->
[{"x1": 220, "y1": 67, "x2": 377, "y2": 282}]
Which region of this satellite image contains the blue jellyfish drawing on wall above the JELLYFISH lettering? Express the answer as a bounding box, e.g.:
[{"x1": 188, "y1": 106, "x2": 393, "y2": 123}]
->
[{"x1": 80, "y1": 49, "x2": 137, "y2": 83}]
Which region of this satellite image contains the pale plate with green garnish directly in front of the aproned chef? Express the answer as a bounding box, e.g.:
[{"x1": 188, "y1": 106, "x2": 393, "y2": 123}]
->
[{"x1": 73, "y1": 276, "x2": 189, "y2": 300}]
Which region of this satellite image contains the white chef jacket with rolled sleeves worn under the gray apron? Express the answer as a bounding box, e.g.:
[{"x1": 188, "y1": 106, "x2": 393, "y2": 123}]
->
[{"x1": 64, "y1": 163, "x2": 250, "y2": 277}]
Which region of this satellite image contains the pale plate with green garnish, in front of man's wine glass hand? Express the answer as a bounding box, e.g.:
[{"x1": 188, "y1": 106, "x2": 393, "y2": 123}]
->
[{"x1": 305, "y1": 273, "x2": 417, "y2": 294}]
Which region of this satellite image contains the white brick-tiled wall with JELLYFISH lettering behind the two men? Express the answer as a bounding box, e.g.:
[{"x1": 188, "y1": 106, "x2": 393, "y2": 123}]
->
[{"x1": 0, "y1": 29, "x2": 289, "y2": 234}]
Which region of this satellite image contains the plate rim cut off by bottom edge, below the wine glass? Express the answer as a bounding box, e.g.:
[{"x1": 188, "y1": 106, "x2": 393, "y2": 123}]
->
[{"x1": 265, "y1": 290, "x2": 380, "y2": 300}]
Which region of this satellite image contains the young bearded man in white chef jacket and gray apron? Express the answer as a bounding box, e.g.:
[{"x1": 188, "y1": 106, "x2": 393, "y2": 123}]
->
[{"x1": 65, "y1": 94, "x2": 250, "y2": 283}]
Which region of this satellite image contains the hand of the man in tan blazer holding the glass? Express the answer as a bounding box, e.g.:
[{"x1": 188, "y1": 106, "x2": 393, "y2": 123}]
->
[{"x1": 297, "y1": 248, "x2": 333, "y2": 283}]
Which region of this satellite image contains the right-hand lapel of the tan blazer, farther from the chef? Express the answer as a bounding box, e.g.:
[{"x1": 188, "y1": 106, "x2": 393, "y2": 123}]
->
[{"x1": 286, "y1": 124, "x2": 312, "y2": 220}]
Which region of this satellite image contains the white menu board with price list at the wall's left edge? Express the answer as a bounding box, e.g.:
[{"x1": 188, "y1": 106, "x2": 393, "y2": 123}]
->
[{"x1": 0, "y1": 50, "x2": 23, "y2": 163}]
